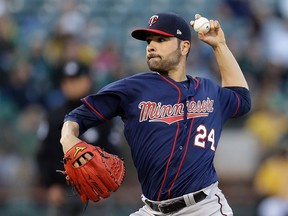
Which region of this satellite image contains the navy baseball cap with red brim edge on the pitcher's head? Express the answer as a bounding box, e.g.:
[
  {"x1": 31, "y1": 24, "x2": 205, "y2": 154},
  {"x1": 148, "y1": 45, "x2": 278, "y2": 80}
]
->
[{"x1": 131, "y1": 12, "x2": 191, "y2": 42}]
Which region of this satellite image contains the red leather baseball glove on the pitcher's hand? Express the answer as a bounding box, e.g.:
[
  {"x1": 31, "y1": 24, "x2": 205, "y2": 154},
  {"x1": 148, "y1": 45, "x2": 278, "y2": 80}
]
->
[{"x1": 63, "y1": 142, "x2": 125, "y2": 203}]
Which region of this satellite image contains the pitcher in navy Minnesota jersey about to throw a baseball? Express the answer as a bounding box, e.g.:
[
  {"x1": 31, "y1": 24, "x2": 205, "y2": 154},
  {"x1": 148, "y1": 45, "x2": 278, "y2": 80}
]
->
[{"x1": 61, "y1": 12, "x2": 251, "y2": 216}]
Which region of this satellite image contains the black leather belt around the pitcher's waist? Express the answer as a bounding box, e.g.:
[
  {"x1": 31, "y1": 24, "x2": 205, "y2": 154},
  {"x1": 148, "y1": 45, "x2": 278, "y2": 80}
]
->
[{"x1": 145, "y1": 191, "x2": 207, "y2": 214}]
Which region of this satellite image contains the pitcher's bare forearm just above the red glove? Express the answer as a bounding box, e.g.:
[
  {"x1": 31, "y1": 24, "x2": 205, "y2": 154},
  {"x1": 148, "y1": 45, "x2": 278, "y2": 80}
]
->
[{"x1": 60, "y1": 121, "x2": 82, "y2": 154}]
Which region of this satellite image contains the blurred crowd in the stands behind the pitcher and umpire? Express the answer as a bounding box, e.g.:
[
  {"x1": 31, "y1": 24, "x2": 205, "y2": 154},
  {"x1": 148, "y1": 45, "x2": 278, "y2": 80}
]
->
[{"x1": 0, "y1": 0, "x2": 288, "y2": 216}]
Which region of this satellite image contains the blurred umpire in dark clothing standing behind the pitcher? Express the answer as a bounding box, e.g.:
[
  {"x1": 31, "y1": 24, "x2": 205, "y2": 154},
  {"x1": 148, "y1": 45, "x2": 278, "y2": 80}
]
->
[{"x1": 36, "y1": 61, "x2": 119, "y2": 216}]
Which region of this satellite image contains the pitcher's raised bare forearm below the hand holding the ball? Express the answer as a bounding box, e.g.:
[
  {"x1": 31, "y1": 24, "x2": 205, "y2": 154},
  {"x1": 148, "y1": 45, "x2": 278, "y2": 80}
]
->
[{"x1": 214, "y1": 43, "x2": 249, "y2": 89}]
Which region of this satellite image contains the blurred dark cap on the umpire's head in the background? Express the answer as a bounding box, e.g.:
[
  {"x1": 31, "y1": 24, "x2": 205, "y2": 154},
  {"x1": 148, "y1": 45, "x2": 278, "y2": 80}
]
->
[{"x1": 59, "y1": 60, "x2": 90, "y2": 79}]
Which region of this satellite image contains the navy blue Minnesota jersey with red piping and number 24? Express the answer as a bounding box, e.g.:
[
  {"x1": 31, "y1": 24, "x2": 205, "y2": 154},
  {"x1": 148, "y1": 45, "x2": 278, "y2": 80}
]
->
[{"x1": 65, "y1": 72, "x2": 250, "y2": 200}]
